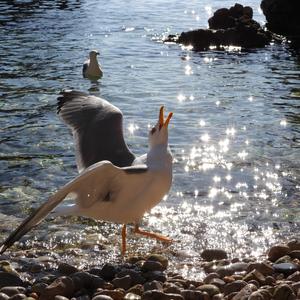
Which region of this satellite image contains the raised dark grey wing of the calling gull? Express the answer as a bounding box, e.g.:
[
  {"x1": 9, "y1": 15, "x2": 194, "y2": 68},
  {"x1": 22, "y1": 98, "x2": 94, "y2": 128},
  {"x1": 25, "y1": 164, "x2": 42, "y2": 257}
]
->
[{"x1": 57, "y1": 91, "x2": 135, "y2": 170}]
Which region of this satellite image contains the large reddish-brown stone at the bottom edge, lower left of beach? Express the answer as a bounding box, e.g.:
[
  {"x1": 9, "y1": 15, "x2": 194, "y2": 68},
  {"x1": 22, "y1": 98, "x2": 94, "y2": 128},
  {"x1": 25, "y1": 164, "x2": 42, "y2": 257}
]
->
[{"x1": 40, "y1": 276, "x2": 75, "y2": 300}]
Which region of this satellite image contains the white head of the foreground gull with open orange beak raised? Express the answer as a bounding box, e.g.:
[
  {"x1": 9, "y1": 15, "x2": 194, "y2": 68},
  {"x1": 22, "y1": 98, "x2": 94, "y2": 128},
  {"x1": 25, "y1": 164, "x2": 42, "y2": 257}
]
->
[{"x1": 149, "y1": 106, "x2": 173, "y2": 148}]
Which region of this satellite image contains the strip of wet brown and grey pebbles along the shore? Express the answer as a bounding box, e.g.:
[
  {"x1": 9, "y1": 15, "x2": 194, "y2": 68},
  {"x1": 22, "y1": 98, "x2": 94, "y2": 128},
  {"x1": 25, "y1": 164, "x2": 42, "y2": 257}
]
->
[{"x1": 0, "y1": 240, "x2": 300, "y2": 300}]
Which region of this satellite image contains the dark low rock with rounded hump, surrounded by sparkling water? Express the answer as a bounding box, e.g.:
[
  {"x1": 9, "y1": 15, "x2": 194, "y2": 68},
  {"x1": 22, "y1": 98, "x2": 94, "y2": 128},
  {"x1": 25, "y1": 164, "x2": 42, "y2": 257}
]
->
[{"x1": 166, "y1": 4, "x2": 272, "y2": 51}]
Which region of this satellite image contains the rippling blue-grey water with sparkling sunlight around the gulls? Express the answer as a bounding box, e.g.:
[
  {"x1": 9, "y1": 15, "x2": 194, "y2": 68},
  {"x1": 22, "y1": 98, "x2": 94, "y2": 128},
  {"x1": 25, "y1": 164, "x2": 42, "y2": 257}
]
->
[{"x1": 0, "y1": 0, "x2": 300, "y2": 274}]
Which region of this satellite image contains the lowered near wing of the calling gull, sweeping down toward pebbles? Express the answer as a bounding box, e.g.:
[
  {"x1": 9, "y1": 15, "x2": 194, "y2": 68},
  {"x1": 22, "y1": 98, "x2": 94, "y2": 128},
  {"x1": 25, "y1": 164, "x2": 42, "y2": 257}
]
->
[{"x1": 0, "y1": 161, "x2": 136, "y2": 254}]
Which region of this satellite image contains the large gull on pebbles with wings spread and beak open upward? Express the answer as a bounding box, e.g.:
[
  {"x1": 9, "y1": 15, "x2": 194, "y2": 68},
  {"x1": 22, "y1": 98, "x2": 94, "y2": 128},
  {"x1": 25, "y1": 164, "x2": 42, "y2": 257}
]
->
[{"x1": 0, "y1": 90, "x2": 173, "y2": 255}]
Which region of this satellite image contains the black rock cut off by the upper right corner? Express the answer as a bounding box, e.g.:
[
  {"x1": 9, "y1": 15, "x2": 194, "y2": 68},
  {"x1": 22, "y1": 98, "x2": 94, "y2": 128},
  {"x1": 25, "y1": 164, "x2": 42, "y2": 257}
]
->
[{"x1": 261, "y1": 0, "x2": 300, "y2": 46}]
